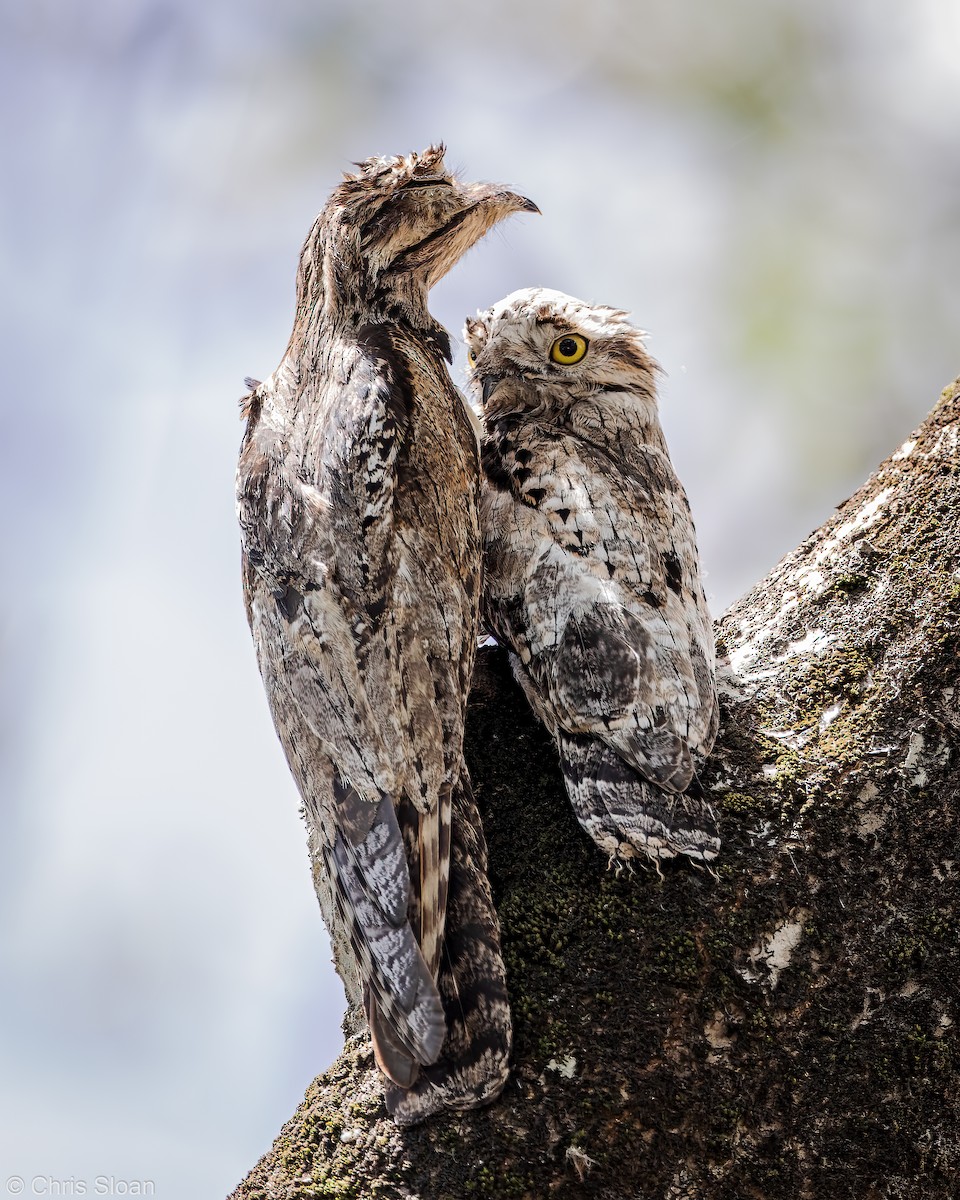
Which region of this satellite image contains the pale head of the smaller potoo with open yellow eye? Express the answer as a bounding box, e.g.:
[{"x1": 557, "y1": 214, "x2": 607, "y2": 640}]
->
[{"x1": 463, "y1": 288, "x2": 658, "y2": 414}]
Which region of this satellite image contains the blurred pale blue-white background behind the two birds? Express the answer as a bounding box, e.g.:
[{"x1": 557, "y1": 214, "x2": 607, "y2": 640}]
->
[{"x1": 0, "y1": 0, "x2": 960, "y2": 1200}]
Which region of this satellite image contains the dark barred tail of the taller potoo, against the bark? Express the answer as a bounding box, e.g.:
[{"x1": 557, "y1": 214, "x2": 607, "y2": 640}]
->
[{"x1": 385, "y1": 773, "x2": 512, "y2": 1126}]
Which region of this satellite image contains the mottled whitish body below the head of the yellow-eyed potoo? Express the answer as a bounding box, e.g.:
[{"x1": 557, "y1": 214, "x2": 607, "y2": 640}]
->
[{"x1": 484, "y1": 403, "x2": 719, "y2": 860}]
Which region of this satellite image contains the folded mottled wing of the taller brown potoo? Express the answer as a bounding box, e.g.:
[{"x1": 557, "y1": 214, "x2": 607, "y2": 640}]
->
[{"x1": 238, "y1": 326, "x2": 450, "y2": 1087}]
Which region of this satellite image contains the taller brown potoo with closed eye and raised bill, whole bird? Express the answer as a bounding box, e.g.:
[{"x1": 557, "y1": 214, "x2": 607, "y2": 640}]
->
[{"x1": 236, "y1": 146, "x2": 538, "y2": 1124}]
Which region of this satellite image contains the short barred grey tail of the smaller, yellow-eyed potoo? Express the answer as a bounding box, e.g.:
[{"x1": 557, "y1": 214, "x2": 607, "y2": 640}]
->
[{"x1": 557, "y1": 731, "x2": 720, "y2": 862}]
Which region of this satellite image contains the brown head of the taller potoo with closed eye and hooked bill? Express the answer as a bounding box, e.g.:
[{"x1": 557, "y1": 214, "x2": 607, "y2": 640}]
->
[{"x1": 298, "y1": 145, "x2": 540, "y2": 321}]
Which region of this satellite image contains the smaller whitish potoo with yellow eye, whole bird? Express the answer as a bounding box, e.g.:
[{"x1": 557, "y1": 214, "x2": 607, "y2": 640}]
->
[{"x1": 466, "y1": 288, "x2": 720, "y2": 860}]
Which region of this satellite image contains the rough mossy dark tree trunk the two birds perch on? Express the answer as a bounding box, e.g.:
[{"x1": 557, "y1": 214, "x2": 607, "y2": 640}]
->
[{"x1": 233, "y1": 380, "x2": 960, "y2": 1200}]
